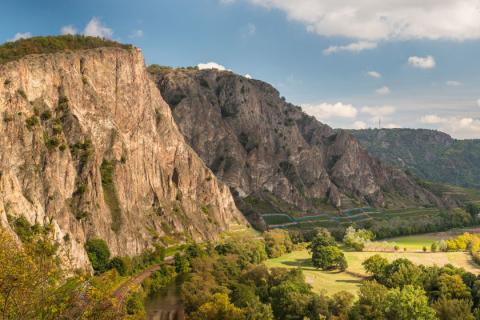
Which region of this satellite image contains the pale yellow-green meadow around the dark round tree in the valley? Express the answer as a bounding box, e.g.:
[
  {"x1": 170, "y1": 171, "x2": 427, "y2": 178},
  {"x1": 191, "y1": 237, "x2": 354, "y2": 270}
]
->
[{"x1": 266, "y1": 250, "x2": 480, "y2": 295}]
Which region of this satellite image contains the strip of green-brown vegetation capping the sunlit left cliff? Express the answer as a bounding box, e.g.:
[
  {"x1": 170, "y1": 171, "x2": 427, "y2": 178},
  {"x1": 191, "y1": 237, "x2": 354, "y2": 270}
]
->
[{"x1": 0, "y1": 35, "x2": 132, "y2": 64}]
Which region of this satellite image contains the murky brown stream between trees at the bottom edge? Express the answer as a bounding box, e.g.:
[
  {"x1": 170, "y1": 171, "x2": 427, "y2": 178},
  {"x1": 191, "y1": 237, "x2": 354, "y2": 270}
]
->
[{"x1": 145, "y1": 279, "x2": 185, "y2": 320}]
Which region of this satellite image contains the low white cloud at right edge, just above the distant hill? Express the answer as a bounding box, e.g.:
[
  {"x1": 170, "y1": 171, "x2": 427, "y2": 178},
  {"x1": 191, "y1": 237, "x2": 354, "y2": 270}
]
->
[{"x1": 420, "y1": 114, "x2": 480, "y2": 139}]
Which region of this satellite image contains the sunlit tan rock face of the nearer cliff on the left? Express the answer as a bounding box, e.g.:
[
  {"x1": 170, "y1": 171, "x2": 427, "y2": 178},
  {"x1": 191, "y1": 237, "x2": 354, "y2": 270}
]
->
[{"x1": 0, "y1": 48, "x2": 246, "y2": 267}]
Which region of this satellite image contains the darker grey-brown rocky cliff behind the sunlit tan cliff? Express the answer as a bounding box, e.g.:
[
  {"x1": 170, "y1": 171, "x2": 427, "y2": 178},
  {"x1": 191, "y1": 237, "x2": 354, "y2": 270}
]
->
[{"x1": 150, "y1": 67, "x2": 446, "y2": 224}]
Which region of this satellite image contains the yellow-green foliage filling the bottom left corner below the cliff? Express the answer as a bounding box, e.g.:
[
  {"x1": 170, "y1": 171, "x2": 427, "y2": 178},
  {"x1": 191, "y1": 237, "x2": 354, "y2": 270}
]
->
[{"x1": 0, "y1": 227, "x2": 125, "y2": 320}]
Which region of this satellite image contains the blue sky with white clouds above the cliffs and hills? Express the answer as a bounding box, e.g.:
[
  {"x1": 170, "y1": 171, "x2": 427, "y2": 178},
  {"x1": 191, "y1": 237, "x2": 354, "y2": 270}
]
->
[{"x1": 0, "y1": 0, "x2": 480, "y2": 139}]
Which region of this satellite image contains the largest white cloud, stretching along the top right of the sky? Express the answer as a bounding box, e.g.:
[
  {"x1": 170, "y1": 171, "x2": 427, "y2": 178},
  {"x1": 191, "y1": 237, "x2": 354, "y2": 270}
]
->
[{"x1": 246, "y1": 0, "x2": 480, "y2": 41}]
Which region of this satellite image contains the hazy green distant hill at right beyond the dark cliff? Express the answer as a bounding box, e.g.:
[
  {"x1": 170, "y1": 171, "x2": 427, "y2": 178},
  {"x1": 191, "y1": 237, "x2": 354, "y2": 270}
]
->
[{"x1": 351, "y1": 129, "x2": 480, "y2": 188}]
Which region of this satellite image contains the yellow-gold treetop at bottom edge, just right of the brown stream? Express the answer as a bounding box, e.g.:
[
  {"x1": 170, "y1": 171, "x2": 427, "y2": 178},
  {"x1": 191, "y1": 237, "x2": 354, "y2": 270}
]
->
[{"x1": 190, "y1": 293, "x2": 245, "y2": 320}]
